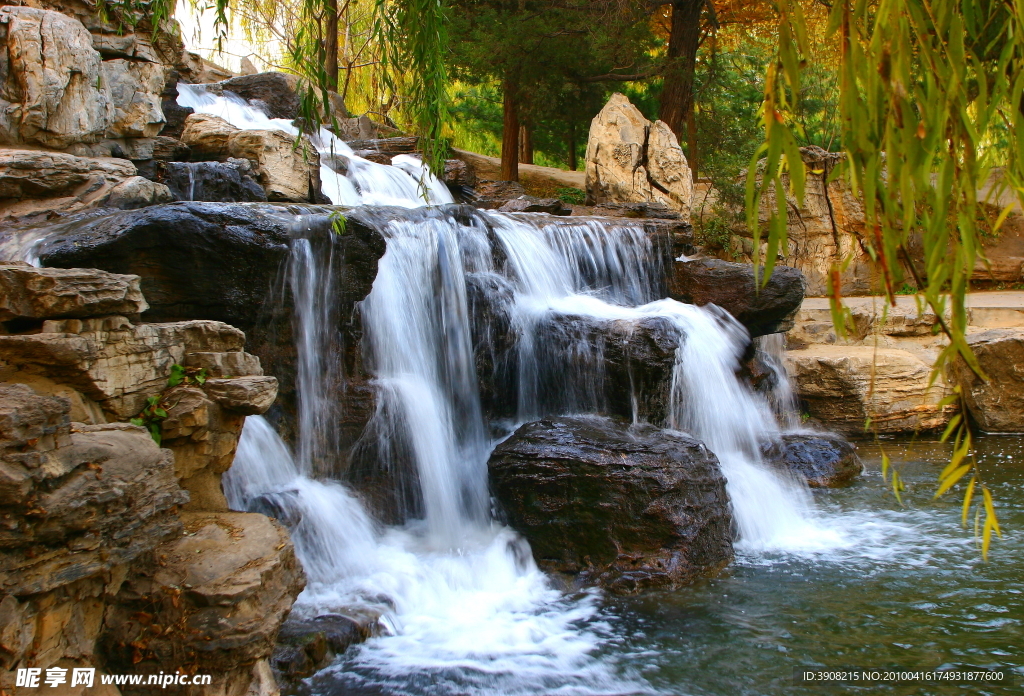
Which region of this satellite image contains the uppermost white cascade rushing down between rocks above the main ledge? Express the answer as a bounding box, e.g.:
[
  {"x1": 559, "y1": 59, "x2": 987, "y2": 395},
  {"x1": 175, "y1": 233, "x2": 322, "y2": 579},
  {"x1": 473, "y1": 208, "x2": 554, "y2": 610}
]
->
[{"x1": 177, "y1": 82, "x2": 453, "y2": 208}]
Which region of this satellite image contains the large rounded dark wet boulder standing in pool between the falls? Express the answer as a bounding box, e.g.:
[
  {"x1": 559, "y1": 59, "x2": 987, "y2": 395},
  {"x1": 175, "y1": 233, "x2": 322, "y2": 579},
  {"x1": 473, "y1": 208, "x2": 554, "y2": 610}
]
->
[{"x1": 487, "y1": 417, "x2": 732, "y2": 593}]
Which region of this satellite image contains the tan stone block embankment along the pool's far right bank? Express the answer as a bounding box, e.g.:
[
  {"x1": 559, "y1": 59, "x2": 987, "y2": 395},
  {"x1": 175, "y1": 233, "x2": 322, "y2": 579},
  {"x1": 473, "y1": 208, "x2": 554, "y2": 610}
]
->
[{"x1": 786, "y1": 292, "x2": 1024, "y2": 434}]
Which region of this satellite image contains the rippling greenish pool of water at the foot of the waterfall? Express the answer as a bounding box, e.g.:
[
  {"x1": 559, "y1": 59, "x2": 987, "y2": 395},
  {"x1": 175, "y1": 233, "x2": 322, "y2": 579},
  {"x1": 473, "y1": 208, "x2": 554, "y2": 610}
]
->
[{"x1": 307, "y1": 436, "x2": 1024, "y2": 696}]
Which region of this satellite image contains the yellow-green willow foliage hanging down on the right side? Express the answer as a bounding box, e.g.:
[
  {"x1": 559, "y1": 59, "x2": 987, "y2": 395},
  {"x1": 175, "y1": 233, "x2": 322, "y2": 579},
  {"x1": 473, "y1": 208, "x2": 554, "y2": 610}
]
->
[{"x1": 746, "y1": 0, "x2": 1024, "y2": 558}]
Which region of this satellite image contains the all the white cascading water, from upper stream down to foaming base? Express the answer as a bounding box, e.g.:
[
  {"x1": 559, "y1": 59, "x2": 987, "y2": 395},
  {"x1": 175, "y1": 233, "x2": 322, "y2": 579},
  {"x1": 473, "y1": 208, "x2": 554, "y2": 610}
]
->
[{"x1": 179, "y1": 80, "x2": 829, "y2": 695}]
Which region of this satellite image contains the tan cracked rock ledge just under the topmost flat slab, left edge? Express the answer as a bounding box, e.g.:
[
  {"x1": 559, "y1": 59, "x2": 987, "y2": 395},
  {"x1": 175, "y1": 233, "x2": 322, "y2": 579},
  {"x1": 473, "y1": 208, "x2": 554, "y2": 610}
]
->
[{"x1": 0, "y1": 316, "x2": 245, "y2": 420}]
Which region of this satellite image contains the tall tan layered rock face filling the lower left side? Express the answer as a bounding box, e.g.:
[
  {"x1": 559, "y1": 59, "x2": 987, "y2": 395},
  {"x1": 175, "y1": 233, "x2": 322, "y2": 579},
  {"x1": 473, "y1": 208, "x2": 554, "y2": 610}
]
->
[{"x1": 0, "y1": 265, "x2": 304, "y2": 696}]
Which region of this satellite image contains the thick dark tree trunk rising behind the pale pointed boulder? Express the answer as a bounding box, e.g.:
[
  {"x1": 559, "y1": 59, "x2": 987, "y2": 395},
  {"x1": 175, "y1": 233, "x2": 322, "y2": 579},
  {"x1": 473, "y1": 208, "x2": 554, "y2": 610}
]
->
[{"x1": 659, "y1": 0, "x2": 706, "y2": 142}]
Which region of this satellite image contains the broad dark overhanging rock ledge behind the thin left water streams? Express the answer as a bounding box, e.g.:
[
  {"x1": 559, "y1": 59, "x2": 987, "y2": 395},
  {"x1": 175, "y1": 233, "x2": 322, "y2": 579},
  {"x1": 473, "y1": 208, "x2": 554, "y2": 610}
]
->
[{"x1": 33, "y1": 203, "x2": 387, "y2": 448}]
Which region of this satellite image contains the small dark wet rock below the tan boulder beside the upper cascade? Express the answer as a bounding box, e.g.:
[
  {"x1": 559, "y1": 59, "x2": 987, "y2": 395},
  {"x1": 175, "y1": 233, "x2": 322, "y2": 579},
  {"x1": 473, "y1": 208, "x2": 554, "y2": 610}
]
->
[{"x1": 161, "y1": 158, "x2": 266, "y2": 203}]
